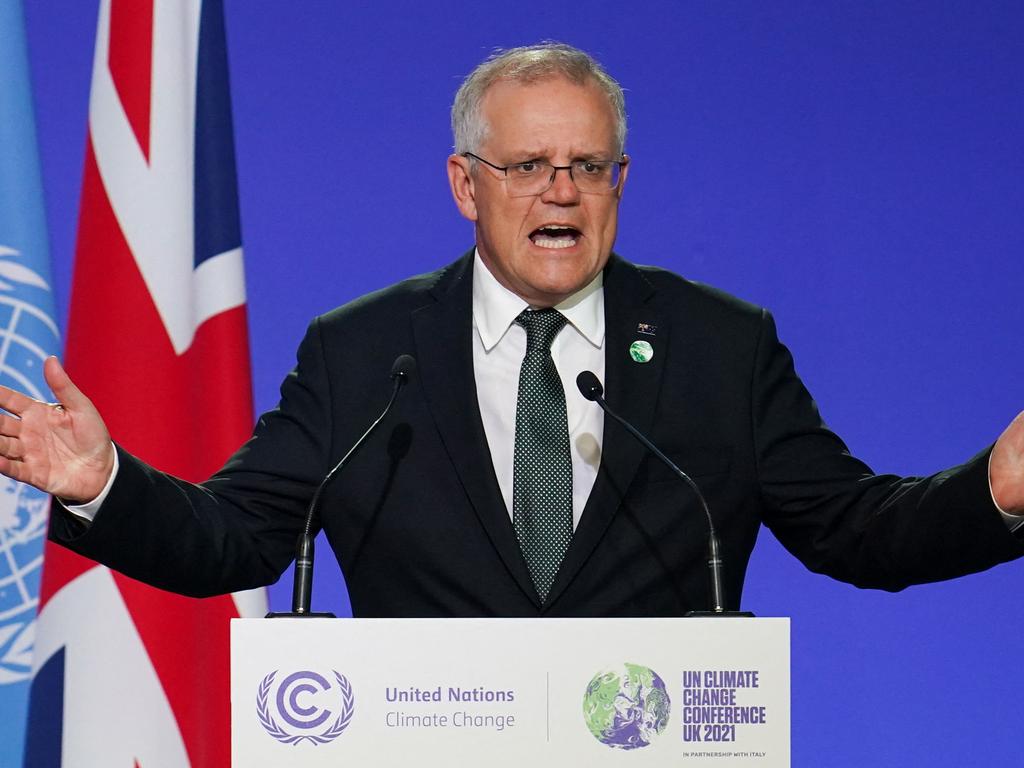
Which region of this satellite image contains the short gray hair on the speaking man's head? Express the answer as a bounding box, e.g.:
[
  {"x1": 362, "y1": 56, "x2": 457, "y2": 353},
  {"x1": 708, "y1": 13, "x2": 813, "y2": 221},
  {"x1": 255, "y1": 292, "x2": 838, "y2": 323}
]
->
[{"x1": 452, "y1": 42, "x2": 626, "y2": 155}]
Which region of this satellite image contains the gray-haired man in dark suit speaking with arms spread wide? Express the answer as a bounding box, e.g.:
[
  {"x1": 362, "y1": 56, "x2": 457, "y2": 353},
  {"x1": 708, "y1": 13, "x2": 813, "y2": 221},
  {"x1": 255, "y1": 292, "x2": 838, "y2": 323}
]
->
[{"x1": 0, "y1": 45, "x2": 1024, "y2": 616}]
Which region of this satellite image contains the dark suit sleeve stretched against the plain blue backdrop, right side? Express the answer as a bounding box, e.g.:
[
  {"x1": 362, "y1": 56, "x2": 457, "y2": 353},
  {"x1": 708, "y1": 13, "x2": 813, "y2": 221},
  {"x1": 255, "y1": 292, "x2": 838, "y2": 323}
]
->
[{"x1": 751, "y1": 312, "x2": 1024, "y2": 591}]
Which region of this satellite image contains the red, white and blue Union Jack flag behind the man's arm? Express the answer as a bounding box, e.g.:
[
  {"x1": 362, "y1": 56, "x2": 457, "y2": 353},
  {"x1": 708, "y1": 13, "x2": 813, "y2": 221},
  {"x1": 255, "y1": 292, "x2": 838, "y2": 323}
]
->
[{"x1": 26, "y1": 0, "x2": 266, "y2": 768}]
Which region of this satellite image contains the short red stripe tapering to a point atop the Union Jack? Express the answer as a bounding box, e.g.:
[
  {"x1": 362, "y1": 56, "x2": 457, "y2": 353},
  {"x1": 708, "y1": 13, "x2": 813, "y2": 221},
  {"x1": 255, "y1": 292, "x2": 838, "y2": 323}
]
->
[{"x1": 108, "y1": 0, "x2": 153, "y2": 161}]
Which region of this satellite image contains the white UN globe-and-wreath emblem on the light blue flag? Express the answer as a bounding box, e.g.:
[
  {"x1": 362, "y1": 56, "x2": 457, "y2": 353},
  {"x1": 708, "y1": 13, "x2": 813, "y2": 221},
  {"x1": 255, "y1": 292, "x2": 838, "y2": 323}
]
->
[{"x1": 0, "y1": 246, "x2": 58, "y2": 685}]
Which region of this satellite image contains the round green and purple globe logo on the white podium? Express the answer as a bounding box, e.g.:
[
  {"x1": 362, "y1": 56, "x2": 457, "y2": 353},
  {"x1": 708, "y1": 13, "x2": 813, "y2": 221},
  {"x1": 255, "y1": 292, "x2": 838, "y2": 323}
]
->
[{"x1": 583, "y1": 664, "x2": 672, "y2": 750}]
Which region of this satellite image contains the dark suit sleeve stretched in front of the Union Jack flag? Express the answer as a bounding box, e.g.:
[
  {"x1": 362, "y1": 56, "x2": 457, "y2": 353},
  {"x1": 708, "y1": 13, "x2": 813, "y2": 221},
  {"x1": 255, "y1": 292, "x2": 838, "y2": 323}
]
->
[{"x1": 50, "y1": 321, "x2": 332, "y2": 597}]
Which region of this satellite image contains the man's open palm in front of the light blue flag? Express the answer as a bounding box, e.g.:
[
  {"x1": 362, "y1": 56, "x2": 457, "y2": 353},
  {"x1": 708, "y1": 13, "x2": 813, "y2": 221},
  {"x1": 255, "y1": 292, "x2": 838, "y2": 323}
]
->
[{"x1": 0, "y1": 356, "x2": 114, "y2": 503}]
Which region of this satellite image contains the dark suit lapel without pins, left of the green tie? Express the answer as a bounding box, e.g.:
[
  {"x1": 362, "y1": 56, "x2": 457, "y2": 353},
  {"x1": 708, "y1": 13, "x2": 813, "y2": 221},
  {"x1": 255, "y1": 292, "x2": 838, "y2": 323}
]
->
[{"x1": 413, "y1": 251, "x2": 540, "y2": 607}]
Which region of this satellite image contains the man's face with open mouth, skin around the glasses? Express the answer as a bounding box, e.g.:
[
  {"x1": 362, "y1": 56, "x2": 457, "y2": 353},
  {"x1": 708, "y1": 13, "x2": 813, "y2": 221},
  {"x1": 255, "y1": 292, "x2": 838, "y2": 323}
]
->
[{"x1": 449, "y1": 77, "x2": 626, "y2": 306}]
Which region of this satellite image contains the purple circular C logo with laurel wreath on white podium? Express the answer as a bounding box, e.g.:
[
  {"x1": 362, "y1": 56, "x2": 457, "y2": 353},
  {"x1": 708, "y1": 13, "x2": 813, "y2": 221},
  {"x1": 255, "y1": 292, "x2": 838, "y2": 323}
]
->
[{"x1": 256, "y1": 670, "x2": 355, "y2": 746}]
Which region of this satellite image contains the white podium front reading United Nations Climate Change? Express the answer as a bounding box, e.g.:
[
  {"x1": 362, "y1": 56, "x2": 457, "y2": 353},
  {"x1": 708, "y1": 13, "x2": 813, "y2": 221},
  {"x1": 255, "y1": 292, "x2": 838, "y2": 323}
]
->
[{"x1": 231, "y1": 618, "x2": 790, "y2": 768}]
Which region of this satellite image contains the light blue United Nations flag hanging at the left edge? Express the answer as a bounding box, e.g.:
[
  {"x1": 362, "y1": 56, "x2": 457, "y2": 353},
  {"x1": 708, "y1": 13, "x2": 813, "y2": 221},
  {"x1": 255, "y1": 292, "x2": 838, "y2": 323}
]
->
[{"x1": 0, "y1": 0, "x2": 58, "y2": 768}]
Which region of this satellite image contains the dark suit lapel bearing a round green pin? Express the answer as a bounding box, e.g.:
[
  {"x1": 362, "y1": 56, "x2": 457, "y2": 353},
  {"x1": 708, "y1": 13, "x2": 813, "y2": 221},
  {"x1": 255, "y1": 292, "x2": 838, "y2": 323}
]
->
[{"x1": 547, "y1": 255, "x2": 670, "y2": 607}]
